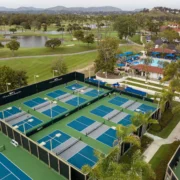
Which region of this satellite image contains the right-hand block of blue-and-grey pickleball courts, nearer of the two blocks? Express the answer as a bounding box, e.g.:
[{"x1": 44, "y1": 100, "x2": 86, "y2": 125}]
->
[{"x1": 30, "y1": 88, "x2": 157, "y2": 169}]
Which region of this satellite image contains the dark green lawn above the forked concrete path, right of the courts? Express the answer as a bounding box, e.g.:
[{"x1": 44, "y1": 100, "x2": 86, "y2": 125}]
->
[{"x1": 149, "y1": 102, "x2": 180, "y2": 138}]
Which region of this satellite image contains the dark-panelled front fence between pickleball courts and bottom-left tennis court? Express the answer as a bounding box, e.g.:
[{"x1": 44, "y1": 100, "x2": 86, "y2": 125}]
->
[{"x1": 0, "y1": 121, "x2": 87, "y2": 180}]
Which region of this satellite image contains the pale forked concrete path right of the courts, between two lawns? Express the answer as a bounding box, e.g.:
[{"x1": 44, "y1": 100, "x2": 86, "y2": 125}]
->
[{"x1": 143, "y1": 121, "x2": 180, "y2": 162}]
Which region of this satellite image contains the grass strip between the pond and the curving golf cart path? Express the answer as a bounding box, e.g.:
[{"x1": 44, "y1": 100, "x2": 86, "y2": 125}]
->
[{"x1": 0, "y1": 42, "x2": 96, "y2": 58}]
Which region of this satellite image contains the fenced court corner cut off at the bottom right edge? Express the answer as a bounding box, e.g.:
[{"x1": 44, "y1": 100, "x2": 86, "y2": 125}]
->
[{"x1": 164, "y1": 146, "x2": 180, "y2": 180}]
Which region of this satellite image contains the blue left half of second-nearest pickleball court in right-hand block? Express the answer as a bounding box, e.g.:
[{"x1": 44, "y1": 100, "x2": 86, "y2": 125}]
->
[{"x1": 68, "y1": 116, "x2": 95, "y2": 131}]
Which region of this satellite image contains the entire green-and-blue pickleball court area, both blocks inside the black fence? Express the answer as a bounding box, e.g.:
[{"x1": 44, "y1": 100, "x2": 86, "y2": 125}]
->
[{"x1": 0, "y1": 81, "x2": 157, "y2": 174}]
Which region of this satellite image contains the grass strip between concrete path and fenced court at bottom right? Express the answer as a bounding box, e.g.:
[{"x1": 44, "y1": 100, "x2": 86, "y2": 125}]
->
[{"x1": 150, "y1": 141, "x2": 180, "y2": 180}]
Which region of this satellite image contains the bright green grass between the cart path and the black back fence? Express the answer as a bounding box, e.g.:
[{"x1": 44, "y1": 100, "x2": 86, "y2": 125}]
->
[{"x1": 0, "y1": 52, "x2": 97, "y2": 84}]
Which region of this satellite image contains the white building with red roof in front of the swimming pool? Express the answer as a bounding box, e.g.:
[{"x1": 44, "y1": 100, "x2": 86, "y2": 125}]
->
[{"x1": 131, "y1": 64, "x2": 163, "y2": 79}]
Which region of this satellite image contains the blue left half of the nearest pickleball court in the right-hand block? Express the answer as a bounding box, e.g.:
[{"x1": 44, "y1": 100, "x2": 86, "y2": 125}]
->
[{"x1": 38, "y1": 130, "x2": 71, "y2": 150}]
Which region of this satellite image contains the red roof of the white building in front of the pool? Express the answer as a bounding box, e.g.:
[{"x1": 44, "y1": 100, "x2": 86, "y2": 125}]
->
[{"x1": 131, "y1": 64, "x2": 163, "y2": 74}]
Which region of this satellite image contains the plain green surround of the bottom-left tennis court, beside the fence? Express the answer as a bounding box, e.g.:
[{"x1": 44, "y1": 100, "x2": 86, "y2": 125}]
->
[{"x1": 0, "y1": 132, "x2": 65, "y2": 180}]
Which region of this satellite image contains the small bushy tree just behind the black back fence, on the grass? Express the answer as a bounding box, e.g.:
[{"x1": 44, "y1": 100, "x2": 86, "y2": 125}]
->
[{"x1": 51, "y1": 57, "x2": 68, "y2": 76}]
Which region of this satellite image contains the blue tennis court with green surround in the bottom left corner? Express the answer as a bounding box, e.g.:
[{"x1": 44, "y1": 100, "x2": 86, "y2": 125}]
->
[{"x1": 0, "y1": 132, "x2": 65, "y2": 180}]
